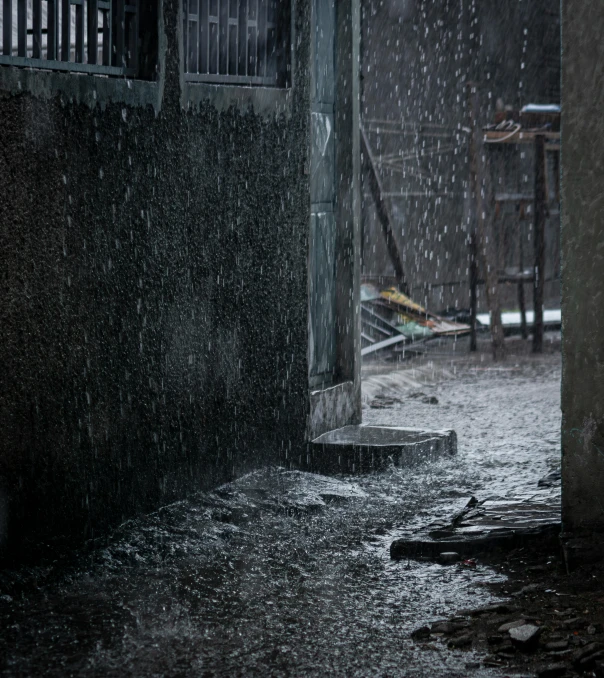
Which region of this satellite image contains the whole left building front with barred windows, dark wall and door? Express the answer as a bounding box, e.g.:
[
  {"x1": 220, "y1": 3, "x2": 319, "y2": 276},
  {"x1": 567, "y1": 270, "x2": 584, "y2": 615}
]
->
[{"x1": 0, "y1": 0, "x2": 360, "y2": 552}]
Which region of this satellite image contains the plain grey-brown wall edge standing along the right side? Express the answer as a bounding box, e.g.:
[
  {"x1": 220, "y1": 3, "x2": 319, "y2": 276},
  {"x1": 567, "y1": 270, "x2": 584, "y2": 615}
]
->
[{"x1": 562, "y1": 0, "x2": 604, "y2": 536}]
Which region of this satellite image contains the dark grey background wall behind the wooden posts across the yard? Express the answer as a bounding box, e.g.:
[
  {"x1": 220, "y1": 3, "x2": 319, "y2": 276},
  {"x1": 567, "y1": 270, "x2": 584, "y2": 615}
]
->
[{"x1": 361, "y1": 0, "x2": 560, "y2": 311}]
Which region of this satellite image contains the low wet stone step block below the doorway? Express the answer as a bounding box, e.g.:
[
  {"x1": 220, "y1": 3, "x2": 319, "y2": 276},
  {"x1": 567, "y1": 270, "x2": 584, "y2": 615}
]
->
[{"x1": 308, "y1": 426, "x2": 457, "y2": 474}]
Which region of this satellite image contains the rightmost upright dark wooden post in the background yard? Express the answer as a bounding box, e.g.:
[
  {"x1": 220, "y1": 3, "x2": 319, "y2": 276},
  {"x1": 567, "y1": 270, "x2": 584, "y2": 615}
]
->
[{"x1": 533, "y1": 134, "x2": 547, "y2": 353}]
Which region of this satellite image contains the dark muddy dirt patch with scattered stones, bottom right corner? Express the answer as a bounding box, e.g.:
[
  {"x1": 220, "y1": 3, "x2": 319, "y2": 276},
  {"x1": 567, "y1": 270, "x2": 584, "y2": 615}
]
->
[{"x1": 424, "y1": 545, "x2": 604, "y2": 678}]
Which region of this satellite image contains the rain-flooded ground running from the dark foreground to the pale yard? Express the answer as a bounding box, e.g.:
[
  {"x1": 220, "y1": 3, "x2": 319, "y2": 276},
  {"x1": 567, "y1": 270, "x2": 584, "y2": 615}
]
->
[{"x1": 0, "y1": 338, "x2": 560, "y2": 678}]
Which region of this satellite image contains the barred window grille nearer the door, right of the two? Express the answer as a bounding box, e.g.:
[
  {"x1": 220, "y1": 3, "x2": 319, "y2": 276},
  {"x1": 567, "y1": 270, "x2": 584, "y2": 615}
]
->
[{"x1": 183, "y1": 0, "x2": 290, "y2": 87}]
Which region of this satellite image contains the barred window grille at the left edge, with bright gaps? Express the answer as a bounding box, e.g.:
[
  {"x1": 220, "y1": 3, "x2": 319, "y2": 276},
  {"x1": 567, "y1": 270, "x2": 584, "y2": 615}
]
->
[{"x1": 0, "y1": 0, "x2": 141, "y2": 76}]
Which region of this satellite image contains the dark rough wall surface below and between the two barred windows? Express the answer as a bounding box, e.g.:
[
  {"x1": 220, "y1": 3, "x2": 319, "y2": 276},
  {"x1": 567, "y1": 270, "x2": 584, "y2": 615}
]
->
[{"x1": 0, "y1": 0, "x2": 309, "y2": 560}]
